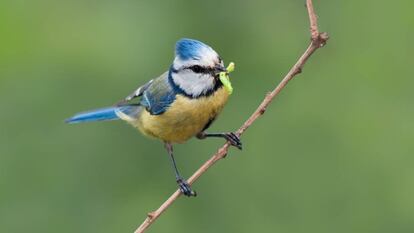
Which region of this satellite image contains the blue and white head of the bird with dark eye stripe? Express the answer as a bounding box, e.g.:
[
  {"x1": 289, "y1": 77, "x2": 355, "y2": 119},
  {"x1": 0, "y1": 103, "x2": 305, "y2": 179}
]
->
[{"x1": 171, "y1": 39, "x2": 226, "y2": 97}]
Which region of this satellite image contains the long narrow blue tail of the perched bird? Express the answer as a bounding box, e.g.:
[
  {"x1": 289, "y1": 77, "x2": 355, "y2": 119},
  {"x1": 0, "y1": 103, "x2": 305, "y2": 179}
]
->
[{"x1": 65, "y1": 105, "x2": 139, "y2": 123}]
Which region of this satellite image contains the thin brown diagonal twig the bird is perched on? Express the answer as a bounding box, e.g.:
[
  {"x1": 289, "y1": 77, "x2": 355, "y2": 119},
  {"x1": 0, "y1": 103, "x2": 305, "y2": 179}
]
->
[{"x1": 135, "y1": 0, "x2": 329, "y2": 233}]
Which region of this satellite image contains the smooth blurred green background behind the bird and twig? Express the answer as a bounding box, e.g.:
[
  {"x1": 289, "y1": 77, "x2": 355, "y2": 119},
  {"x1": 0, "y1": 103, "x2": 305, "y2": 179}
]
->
[{"x1": 0, "y1": 0, "x2": 414, "y2": 233}]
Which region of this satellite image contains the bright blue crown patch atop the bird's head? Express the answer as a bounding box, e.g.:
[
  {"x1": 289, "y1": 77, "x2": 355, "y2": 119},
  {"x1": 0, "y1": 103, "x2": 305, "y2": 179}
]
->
[{"x1": 175, "y1": 38, "x2": 211, "y2": 60}]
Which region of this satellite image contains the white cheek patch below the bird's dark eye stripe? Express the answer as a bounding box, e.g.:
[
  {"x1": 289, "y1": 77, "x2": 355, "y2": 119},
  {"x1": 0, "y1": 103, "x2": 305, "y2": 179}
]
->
[{"x1": 172, "y1": 70, "x2": 214, "y2": 97}]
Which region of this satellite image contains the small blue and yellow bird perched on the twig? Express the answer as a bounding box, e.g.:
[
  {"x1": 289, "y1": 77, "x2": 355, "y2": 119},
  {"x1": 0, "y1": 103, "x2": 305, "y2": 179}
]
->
[{"x1": 66, "y1": 38, "x2": 242, "y2": 197}]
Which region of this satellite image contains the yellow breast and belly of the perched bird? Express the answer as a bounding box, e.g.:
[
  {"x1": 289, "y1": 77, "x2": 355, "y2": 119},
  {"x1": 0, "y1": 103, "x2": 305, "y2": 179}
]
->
[{"x1": 136, "y1": 88, "x2": 229, "y2": 143}]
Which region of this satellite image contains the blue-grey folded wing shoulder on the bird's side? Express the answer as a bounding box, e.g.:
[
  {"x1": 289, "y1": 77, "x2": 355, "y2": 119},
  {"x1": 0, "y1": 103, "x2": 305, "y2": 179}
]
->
[{"x1": 140, "y1": 72, "x2": 177, "y2": 115}]
